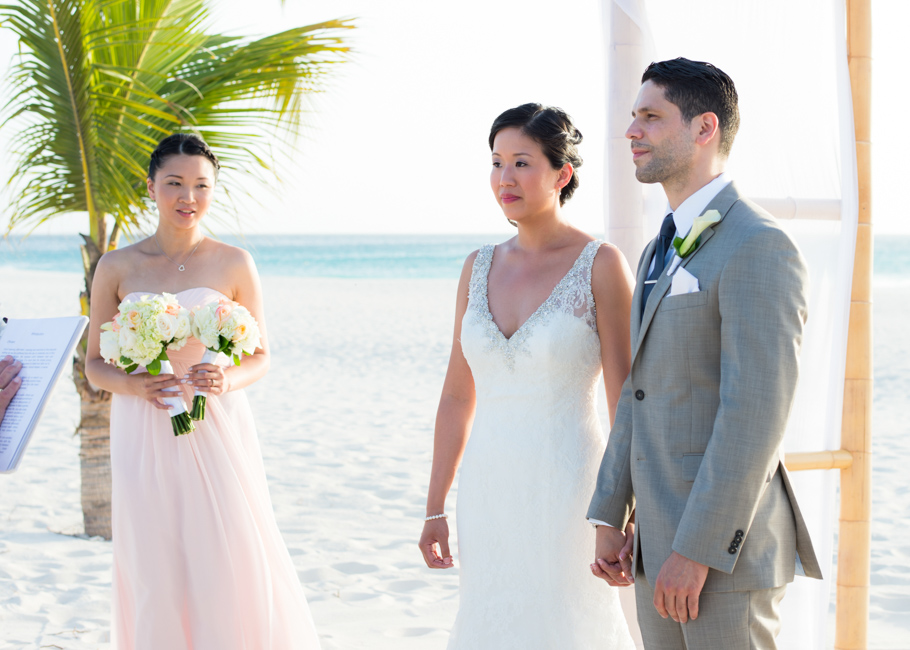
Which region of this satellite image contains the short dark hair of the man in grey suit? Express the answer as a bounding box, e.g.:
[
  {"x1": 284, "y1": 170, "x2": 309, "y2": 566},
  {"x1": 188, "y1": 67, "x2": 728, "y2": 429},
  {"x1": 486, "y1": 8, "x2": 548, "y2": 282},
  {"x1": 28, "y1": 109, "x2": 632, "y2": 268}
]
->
[{"x1": 641, "y1": 57, "x2": 739, "y2": 156}]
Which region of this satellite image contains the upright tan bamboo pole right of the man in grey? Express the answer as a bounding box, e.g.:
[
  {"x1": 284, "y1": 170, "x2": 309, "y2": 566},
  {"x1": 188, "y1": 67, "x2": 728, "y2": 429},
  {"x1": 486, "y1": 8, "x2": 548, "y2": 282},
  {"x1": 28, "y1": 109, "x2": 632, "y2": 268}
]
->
[{"x1": 834, "y1": 0, "x2": 872, "y2": 650}]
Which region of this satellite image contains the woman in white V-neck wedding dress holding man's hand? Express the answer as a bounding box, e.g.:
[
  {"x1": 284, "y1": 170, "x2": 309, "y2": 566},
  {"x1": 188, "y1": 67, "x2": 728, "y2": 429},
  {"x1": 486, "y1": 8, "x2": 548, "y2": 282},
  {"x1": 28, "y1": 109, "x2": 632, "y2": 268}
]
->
[{"x1": 420, "y1": 104, "x2": 634, "y2": 650}]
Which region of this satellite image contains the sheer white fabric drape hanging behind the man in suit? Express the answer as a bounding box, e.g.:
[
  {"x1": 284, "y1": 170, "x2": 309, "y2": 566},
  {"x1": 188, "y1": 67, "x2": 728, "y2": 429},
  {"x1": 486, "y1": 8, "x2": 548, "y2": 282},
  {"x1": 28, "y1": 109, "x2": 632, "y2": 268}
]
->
[{"x1": 603, "y1": 0, "x2": 858, "y2": 650}]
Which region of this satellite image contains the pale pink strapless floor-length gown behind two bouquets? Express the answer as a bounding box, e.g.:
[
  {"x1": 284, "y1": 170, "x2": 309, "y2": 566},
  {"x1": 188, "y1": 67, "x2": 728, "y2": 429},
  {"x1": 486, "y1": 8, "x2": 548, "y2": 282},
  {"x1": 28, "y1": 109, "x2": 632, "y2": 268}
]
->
[{"x1": 111, "y1": 288, "x2": 319, "y2": 650}]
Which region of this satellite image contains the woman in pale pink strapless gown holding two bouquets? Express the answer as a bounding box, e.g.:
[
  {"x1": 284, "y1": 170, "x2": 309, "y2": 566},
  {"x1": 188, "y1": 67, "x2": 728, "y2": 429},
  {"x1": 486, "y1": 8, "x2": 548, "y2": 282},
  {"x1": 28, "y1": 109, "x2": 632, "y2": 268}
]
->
[{"x1": 86, "y1": 133, "x2": 319, "y2": 650}]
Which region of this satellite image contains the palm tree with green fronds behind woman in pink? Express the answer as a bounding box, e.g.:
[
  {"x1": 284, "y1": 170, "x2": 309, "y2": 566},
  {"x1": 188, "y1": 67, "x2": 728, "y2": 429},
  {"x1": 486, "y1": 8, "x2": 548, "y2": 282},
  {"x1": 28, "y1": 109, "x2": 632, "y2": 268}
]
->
[{"x1": 0, "y1": 0, "x2": 353, "y2": 539}]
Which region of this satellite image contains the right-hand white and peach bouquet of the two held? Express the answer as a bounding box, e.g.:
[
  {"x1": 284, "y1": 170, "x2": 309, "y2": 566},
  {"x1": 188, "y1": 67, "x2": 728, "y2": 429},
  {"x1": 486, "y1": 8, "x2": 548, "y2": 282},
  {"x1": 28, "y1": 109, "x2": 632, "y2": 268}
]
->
[{"x1": 190, "y1": 300, "x2": 260, "y2": 420}]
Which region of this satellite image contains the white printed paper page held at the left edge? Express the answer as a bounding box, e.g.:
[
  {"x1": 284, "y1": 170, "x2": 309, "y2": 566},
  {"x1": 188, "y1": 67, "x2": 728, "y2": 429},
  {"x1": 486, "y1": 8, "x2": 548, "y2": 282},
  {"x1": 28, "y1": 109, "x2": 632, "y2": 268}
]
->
[{"x1": 0, "y1": 316, "x2": 87, "y2": 472}]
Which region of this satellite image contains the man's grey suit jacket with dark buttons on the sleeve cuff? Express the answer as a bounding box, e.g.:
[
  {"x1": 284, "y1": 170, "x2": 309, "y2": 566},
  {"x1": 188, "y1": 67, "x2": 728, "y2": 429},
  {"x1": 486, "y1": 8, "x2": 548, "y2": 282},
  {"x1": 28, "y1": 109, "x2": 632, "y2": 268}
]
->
[{"x1": 588, "y1": 183, "x2": 821, "y2": 592}]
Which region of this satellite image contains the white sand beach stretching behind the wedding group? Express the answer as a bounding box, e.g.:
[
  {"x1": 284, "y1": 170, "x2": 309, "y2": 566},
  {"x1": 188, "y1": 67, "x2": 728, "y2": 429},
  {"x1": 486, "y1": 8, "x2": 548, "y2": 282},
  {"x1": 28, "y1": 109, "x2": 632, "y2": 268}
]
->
[{"x1": 0, "y1": 267, "x2": 910, "y2": 650}]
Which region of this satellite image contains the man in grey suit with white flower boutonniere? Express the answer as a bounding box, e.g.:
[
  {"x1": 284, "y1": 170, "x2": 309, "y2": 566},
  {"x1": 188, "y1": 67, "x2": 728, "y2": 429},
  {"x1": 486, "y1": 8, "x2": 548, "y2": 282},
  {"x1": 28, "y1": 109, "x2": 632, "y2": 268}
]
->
[{"x1": 588, "y1": 58, "x2": 821, "y2": 650}]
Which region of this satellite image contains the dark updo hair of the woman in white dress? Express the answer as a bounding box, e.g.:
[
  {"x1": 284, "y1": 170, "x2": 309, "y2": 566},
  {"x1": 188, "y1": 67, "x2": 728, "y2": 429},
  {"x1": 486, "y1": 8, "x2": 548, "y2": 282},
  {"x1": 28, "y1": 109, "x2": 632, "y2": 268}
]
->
[{"x1": 490, "y1": 104, "x2": 582, "y2": 206}]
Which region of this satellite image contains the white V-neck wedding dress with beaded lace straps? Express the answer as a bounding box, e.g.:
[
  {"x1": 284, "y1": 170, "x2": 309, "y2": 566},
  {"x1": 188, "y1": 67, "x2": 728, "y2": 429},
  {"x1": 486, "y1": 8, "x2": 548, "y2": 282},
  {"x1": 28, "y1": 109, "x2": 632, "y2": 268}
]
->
[{"x1": 448, "y1": 241, "x2": 635, "y2": 650}]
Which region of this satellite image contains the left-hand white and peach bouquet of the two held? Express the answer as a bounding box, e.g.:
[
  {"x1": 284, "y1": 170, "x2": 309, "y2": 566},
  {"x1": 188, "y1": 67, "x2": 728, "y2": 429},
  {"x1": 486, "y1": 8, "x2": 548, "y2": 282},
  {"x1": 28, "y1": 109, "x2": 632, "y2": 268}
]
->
[{"x1": 101, "y1": 293, "x2": 196, "y2": 436}]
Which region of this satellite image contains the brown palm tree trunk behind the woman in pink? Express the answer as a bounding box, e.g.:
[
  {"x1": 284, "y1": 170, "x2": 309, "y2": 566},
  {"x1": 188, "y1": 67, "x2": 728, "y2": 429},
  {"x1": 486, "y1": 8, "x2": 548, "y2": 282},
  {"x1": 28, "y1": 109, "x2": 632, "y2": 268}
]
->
[{"x1": 73, "y1": 228, "x2": 111, "y2": 539}]
